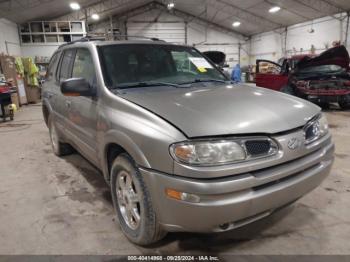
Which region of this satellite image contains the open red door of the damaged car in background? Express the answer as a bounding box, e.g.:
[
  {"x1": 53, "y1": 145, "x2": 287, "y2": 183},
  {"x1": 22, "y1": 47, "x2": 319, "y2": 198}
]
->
[{"x1": 255, "y1": 59, "x2": 288, "y2": 91}]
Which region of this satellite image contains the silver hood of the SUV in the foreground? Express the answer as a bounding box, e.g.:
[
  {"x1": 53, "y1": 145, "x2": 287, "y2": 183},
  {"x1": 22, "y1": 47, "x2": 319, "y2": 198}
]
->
[{"x1": 118, "y1": 83, "x2": 320, "y2": 137}]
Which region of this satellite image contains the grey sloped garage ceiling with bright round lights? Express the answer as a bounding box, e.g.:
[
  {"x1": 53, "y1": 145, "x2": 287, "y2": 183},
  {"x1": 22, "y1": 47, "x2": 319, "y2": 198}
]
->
[{"x1": 0, "y1": 0, "x2": 350, "y2": 36}]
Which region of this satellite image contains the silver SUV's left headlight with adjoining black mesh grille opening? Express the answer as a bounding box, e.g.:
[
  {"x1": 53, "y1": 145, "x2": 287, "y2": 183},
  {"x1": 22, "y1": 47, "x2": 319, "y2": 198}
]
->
[{"x1": 170, "y1": 138, "x2": 278, "y2": 166}]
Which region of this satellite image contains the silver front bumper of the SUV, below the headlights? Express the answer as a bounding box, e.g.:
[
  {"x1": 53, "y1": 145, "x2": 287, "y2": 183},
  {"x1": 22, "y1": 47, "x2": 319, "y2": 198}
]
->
[{"x1": 141, "y1": 137, "x2": 334, "y2": 232}]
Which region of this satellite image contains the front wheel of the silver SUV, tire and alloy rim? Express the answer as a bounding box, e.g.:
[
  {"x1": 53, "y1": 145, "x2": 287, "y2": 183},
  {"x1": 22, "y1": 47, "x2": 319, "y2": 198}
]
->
[{"x1": 111, "y1": 153, "x2": 166, "y2": 245}]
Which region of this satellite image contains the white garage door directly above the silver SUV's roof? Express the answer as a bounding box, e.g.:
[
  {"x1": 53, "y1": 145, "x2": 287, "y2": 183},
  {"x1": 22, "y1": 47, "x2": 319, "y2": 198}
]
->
[{"x1": 127, "y1": 22, "x2": 186, "y2": 44}]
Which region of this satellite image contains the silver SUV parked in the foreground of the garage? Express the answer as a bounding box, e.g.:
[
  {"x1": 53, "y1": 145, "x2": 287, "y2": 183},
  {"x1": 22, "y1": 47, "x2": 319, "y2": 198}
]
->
[{"x1": 43, "y1": 39, "x2": 334, "y2": 245}]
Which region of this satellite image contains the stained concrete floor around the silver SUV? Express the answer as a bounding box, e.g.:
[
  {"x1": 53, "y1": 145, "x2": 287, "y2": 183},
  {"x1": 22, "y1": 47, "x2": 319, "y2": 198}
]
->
[{"x1": 0, "y1": 105, "x2": 350, "y2": 255}]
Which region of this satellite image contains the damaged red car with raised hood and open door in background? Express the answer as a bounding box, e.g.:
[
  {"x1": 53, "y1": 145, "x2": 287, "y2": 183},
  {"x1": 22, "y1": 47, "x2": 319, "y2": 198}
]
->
[{"x1": 256, "y1": 46, "x2": 350, "y2": 109}]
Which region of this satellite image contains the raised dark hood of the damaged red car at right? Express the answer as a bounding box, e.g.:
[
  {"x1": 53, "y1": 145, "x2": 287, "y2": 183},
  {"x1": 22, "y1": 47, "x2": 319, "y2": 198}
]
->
[{"x1": 296, "y1": 45, "x2": 350, "y2": 71}]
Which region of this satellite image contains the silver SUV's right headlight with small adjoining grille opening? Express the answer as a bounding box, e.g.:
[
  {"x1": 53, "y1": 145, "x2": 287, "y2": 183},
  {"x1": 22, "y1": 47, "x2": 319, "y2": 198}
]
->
[{"x1": 304, "y1": 114, "x2": 328, "y2": 144}]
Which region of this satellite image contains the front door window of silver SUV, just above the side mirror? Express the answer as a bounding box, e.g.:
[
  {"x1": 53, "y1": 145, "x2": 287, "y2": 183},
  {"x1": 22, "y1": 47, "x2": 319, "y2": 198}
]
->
[{"x1": 72, "y1": 49, "x2": 95, "y2": 85}]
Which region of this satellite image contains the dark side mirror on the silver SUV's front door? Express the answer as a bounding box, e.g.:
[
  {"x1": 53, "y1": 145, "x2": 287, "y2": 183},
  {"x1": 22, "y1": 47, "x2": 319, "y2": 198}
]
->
[{"x1": 61, "y1": 78, "x2": 95, "y2": 96}]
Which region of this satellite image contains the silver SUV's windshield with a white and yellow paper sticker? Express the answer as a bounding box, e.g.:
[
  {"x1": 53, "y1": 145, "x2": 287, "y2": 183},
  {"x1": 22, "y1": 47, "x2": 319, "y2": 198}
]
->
[{"x1": 100, "y1": 44, "x2": 227, "y2": 88}]
